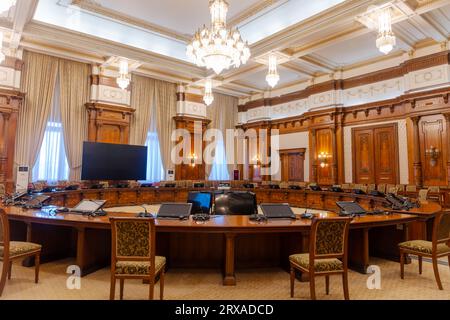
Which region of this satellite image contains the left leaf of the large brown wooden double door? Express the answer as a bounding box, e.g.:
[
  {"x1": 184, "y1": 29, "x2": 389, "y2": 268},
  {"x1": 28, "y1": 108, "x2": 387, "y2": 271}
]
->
[{"x1": 352, "y1": 128, "x2": 375, "y2": 183}]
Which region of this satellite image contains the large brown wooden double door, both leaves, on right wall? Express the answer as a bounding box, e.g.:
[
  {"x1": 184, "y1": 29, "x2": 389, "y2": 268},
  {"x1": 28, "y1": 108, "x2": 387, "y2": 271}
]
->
[{"x1": 352, "y1": 123, "x2": 399, "y2": 184}]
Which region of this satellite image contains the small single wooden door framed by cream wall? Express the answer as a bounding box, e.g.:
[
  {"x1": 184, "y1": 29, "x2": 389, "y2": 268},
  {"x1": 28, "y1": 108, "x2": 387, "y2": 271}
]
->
[{"x1": 280, "y1": 148, "x2": 305, "y2": 181}]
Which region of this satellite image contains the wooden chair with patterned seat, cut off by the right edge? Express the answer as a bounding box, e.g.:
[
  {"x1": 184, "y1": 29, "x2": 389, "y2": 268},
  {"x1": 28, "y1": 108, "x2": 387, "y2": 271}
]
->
[{"x1": 398, "y1": 211, "x2": 450, "y2": 290}]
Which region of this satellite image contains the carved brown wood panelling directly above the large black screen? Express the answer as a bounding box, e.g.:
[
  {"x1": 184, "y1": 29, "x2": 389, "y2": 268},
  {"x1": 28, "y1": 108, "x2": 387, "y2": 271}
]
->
[{"x1": 86, "y1": 102, "x2": 134, "y2": 144}]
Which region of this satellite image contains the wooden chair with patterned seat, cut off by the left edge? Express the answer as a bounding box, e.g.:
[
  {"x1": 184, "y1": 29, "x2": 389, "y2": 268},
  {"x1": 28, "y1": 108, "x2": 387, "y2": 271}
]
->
[{"x1": 0, "y1": 209, "x2": 42, "y2": 296}]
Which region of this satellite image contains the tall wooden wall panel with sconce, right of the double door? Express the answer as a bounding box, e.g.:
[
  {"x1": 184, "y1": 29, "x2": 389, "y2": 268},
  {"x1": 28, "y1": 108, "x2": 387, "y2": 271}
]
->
[{"x1": 419, "y1": 115, "x2": 448, "y2": 186}]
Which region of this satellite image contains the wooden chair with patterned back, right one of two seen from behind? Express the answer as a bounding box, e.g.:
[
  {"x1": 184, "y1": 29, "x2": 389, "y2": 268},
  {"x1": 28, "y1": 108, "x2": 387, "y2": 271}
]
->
[{"x1": 289, "y1": 217, "x2": 352, "y2": 300}]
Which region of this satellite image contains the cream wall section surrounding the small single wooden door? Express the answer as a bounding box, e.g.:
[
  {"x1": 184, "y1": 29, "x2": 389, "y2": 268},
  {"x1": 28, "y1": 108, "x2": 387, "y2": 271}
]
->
[{"x1": 272, "y1": 131, "x2": 309, "y2": 181}]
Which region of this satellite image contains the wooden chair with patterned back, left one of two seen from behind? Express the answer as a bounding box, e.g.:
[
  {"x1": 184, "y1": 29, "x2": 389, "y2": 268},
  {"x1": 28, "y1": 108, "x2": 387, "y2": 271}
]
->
[{"x1": 110, "y1": 218, "x2": 166, "y2": 300}]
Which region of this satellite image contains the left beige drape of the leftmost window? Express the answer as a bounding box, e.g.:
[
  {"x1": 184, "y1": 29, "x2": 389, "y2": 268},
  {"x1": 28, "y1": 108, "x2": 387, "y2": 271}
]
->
[{"x1": 14, "y1": 51, "x2": 58, "y2": 175}]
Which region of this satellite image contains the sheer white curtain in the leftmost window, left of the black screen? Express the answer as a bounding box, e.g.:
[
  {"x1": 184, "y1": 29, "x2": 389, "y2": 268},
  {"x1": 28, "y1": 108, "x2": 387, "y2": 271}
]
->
[{"x1": 33, "y1": 77, "x2": 69, "y2": 182}]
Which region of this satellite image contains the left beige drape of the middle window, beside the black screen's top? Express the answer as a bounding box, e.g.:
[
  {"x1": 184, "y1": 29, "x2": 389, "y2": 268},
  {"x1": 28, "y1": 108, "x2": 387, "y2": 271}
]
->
[{"x1": 130, "y1": 74, "x2": 156, "y2": 145}]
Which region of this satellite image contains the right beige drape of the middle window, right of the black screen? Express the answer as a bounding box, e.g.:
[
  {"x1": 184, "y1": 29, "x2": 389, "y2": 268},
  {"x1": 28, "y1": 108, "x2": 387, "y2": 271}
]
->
[{"x1": 155, "y1": 80, "x2": 177, "y2": 174}]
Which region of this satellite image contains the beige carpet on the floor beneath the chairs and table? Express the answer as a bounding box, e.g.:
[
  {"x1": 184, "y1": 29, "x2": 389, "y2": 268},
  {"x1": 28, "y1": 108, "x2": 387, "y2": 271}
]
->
[{"x1": 0, "y1": 259, "x2": 450, "y2": 300}]
